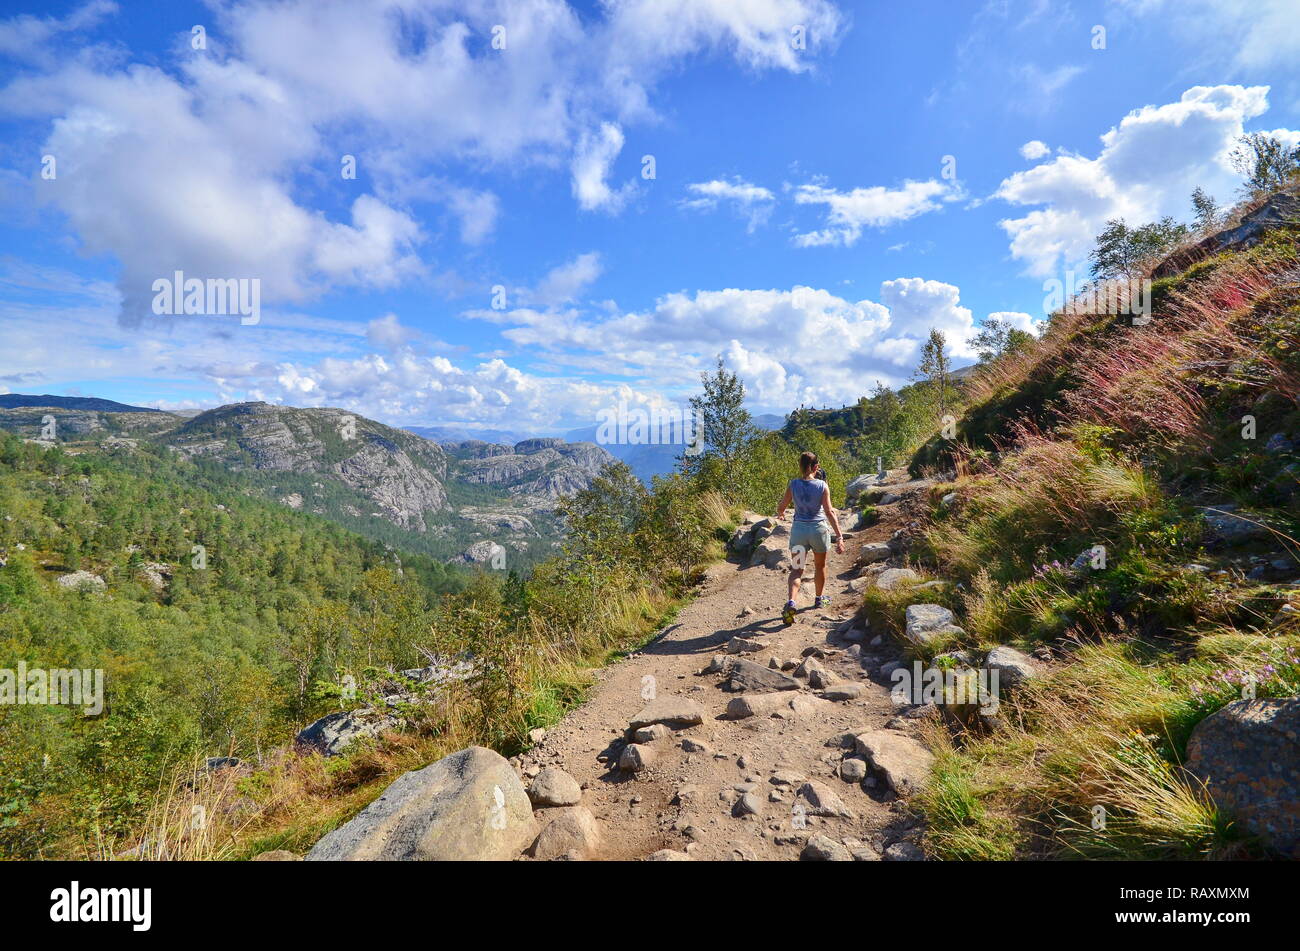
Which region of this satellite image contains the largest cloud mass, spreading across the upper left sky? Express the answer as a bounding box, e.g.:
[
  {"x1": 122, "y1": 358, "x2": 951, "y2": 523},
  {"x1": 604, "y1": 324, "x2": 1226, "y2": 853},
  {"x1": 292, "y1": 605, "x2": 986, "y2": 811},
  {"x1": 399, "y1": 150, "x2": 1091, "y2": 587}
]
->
[{"x1": 0, "y1": 0, "x2": 842, "y2": 320}]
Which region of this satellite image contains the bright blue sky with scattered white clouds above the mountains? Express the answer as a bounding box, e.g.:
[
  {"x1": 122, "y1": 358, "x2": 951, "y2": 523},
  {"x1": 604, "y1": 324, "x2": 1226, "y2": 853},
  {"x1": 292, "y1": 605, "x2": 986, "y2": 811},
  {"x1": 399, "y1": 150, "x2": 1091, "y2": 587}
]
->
[{"x1": 0, "y1": 0, "x2": 1300, "y2": 431}]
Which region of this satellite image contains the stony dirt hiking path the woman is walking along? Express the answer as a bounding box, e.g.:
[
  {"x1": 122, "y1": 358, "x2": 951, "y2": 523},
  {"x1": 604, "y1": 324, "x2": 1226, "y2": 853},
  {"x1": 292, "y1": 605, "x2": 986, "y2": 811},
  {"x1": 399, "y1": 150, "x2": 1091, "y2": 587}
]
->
[{"x1": 512, "y1": 477, "x2": 928, "y2": 860}]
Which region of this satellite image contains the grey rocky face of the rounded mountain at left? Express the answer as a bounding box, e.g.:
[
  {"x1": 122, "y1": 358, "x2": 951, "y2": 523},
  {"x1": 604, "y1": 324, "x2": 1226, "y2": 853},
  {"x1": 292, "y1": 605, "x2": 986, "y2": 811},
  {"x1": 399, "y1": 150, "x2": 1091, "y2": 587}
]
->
[{"x1": 165, "y1": 403, "x2": 447, "y2": 531}]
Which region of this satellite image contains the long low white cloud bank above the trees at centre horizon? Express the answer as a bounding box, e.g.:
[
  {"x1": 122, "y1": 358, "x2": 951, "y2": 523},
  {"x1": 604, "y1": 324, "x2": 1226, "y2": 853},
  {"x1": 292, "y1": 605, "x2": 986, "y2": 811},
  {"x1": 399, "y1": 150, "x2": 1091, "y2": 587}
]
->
[{"x1": 465, "y1": 272, "x2": 975, "y2": 412}]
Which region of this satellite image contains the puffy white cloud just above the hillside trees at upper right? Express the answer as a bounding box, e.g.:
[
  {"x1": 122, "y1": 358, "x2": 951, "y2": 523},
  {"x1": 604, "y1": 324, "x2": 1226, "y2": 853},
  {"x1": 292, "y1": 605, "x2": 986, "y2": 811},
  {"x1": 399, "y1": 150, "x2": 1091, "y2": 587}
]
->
[{"x1": 996, "y1": 86, "x2": 1289, "y2": 277}]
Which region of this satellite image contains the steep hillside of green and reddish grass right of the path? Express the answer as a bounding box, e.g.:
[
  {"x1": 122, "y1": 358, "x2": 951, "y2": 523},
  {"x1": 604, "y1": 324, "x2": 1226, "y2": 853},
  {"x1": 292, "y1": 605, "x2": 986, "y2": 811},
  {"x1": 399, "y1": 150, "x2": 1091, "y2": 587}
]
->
[{"x1": 852, "y1": 189, "x2": 1300, "y2": 859}]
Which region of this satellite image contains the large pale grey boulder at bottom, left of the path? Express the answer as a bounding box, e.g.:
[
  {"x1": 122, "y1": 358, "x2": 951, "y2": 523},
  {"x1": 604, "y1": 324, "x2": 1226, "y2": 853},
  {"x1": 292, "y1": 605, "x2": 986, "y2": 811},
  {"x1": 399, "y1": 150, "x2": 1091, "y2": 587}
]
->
[{"x1": 307, "y1": 746, "x2": 537, "y2": 861}]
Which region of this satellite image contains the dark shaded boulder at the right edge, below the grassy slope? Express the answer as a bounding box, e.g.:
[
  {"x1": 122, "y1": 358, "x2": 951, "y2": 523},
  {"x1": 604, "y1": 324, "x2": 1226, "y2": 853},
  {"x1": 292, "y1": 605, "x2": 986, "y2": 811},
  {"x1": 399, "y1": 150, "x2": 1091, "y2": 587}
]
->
[{"x1": 1187, "y1": 699, "x2": 1300, "y2": 859}]
